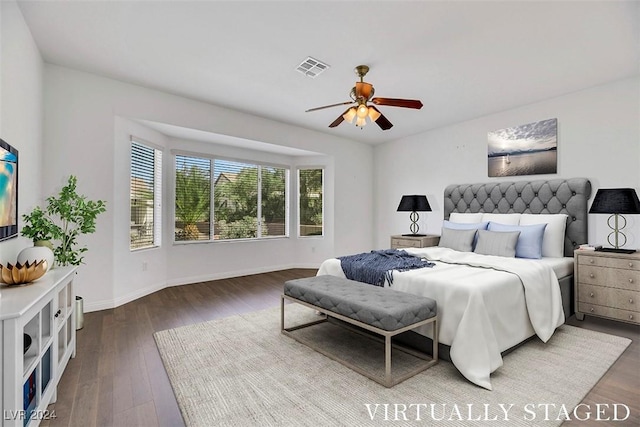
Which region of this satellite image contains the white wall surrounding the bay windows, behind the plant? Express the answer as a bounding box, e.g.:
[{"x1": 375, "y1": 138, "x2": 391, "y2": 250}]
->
[{"x1": 43, "y1": 64, "x2": 373, "y2": 311}]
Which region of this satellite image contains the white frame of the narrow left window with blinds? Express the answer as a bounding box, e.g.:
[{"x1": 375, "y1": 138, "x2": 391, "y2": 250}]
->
[{"x1": 129, "y1": 135, "x2": 163, "y2": 252}]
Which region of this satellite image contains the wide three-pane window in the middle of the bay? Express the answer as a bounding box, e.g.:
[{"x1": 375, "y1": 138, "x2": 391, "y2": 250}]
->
[{"x1": 175, "y1": 155, "x2": 289, "y2": 241}]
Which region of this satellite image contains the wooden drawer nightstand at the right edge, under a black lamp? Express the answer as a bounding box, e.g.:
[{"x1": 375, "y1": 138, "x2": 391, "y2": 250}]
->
[{"x1": 573, "y1": 250, "x2": 640, "y2": 324}]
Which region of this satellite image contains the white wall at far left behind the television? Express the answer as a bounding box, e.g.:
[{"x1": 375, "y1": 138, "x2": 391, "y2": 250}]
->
[{"x1": 0, "y1": 1, "x2": 43, "y2": 264}]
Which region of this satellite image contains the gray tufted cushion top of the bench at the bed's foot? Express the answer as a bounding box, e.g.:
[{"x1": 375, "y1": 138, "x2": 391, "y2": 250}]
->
[{"x1": 284, "y1": 276, "x2": 437, "y2": 331}]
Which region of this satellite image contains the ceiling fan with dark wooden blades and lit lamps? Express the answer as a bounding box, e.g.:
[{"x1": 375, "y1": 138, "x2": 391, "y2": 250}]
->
[{"x1": 305, "y1": 65, "x2": 422, "y2": 130}]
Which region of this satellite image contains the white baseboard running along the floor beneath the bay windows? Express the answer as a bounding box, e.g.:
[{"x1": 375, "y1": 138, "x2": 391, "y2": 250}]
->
[{"x1": 84, "y1": 264, "x2": 319, "y2": 313}]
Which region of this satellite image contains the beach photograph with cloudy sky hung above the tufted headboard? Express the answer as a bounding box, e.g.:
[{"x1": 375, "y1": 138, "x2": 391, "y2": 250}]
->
[{"x1": 487, "y1": 119, "x2": 558, "y2": 177}]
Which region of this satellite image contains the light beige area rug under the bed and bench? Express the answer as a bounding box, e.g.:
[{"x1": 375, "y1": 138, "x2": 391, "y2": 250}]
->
[{"x1": 154, "y1": 304, "x2": 630, "y2": 427}]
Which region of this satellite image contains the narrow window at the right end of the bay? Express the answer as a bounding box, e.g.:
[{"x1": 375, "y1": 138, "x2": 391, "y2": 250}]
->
[{"x1": 298, "y1": 169, "x2": 324, "y2": 237}]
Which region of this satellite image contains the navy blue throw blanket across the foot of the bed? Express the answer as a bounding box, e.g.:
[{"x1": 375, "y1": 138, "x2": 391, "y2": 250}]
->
[{"x1": 338, "y1": 249, "x2": 435, "y2": 286}]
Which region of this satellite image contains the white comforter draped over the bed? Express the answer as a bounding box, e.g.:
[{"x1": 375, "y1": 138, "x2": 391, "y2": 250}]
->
[{"x1": 318, "y1": 247, "x2": 564, "y2": 390}]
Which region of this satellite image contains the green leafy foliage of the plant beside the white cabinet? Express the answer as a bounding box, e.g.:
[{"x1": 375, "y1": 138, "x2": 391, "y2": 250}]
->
[{"x1": 22, "y1": 175, "x2": 106, "y2": 266}]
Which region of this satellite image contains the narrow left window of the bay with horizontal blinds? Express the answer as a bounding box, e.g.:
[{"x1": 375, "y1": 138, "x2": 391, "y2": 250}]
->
[{"x1": 129, "y1": 138, "x2": 162, "y2": 250}]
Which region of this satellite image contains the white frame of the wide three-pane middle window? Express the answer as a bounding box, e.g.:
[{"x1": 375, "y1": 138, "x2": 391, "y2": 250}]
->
[{"x1": 171, "y1": 150, "x2": 292, "y2": 245}]
